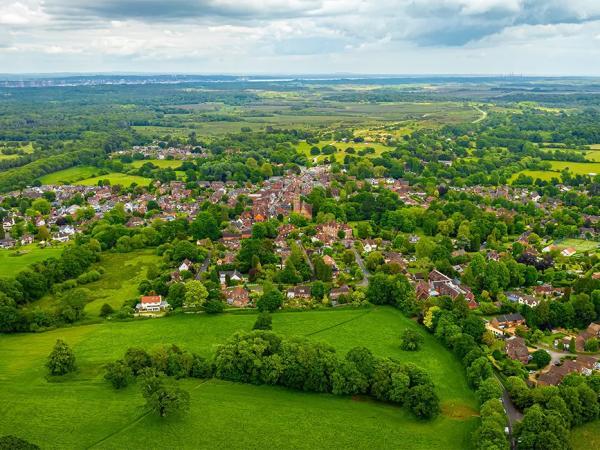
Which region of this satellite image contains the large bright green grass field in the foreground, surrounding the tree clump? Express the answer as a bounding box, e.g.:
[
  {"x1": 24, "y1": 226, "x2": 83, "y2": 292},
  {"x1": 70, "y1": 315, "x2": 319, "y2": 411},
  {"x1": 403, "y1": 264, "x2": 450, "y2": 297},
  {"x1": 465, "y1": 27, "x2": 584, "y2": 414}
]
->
[{"x1": 0, "y1": 307, "x2": 478, "y2": 449}]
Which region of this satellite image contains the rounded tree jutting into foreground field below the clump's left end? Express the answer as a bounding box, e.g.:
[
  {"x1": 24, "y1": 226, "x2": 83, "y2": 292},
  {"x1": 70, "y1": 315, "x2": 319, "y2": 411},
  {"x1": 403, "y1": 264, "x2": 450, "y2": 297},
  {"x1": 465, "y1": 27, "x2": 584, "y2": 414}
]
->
[{"x1": 141, "y1": 368, "x2": 190, "y2": 417}]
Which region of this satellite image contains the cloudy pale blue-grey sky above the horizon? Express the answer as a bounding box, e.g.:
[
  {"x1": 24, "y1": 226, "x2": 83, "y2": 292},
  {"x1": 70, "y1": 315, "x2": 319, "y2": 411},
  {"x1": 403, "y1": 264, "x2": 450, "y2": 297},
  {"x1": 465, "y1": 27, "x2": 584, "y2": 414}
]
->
[{"x1": 0, "y1": 0, "x2": 600, "y2": 76}]
